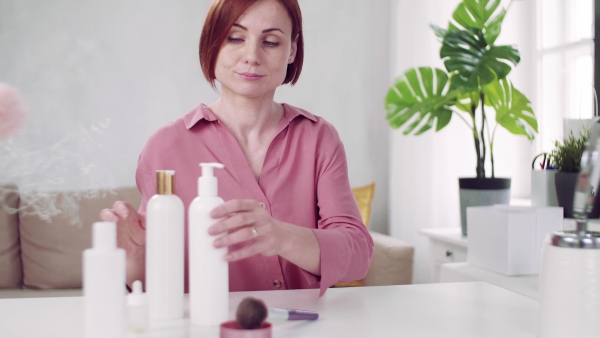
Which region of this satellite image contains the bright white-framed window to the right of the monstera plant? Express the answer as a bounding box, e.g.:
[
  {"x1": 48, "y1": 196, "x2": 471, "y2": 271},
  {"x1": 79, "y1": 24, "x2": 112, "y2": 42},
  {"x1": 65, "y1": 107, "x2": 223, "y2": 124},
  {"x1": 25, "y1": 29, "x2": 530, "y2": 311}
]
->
[{"x1": 536, "y1": 0, "x2": 595, "y2": 151}]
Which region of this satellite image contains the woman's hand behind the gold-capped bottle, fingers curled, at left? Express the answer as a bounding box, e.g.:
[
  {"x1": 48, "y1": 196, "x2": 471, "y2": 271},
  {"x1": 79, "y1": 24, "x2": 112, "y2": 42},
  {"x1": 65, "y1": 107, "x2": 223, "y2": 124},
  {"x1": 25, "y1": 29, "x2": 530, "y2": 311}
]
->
[{"x1": 100, "y1": 201, "x2": 146, "y2": 285}]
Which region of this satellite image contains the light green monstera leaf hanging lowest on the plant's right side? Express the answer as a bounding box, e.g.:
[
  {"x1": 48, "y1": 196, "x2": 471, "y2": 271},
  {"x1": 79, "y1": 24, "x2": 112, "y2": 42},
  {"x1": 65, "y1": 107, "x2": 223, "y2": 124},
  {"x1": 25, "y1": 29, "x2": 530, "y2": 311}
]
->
[{"x1": 483, "y1": 79, "x2": 538, "y2": 140}]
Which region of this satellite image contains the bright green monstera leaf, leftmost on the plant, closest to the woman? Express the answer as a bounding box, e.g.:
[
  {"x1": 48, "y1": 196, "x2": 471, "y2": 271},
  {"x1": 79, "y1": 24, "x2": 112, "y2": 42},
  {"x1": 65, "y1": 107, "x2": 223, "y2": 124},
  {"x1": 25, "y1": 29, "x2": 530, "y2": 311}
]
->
[{"x1": 385, "y1": 67, "x2": 456, "y2": 135}]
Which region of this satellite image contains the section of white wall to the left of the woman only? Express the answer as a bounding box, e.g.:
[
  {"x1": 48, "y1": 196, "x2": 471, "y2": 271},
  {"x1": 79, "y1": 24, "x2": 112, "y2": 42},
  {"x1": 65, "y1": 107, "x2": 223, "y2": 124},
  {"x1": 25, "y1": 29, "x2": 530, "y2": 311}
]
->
[{"x1": 0, "y1": 0, "x2": 216, "y2": 190}]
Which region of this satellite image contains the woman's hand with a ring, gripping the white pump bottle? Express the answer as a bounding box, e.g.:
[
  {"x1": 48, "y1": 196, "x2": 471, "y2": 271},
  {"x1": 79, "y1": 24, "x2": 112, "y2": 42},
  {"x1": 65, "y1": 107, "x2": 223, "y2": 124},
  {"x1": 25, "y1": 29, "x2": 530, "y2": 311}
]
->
[{"x1": 208, "y1": 199, "x2": 292, "y2": 261}]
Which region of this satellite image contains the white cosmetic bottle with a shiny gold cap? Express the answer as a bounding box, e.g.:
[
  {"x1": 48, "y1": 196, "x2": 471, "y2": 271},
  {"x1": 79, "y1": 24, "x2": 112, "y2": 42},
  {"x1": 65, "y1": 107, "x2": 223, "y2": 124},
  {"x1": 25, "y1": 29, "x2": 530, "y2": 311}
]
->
[{"x1": 146, "y1": 170, "x2": 185, "y2": 321}]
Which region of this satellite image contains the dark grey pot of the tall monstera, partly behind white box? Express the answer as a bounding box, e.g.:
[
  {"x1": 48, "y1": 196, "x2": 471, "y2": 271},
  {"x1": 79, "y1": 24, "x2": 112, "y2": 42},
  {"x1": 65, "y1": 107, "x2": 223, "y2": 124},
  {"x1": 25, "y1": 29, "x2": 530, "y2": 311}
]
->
[{"x1": 458, "y1": 178, "x2": 510, "y2": 236}]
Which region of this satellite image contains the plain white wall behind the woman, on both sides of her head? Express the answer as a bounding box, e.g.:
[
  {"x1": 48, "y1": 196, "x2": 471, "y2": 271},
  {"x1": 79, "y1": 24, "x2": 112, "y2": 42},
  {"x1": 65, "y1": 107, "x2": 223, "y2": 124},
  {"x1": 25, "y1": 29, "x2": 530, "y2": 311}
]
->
[{"x1": 0, "y1": 0, "x2": 390, "y2": 232}]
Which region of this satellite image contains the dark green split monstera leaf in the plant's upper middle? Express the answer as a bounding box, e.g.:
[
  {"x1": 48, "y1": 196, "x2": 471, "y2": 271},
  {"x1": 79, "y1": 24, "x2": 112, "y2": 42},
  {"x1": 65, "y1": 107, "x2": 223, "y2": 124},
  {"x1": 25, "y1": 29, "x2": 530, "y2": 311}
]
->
[{"x1": 440, "y1": 28, "x2": 521, "y2": 90}]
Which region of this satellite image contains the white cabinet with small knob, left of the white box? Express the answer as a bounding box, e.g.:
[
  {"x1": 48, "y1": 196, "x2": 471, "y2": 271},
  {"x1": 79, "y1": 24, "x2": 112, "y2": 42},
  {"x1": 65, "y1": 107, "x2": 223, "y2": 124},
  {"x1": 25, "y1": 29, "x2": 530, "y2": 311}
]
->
[{"x1": 419, "y1": 228, "x2": 468, "y2": 283}]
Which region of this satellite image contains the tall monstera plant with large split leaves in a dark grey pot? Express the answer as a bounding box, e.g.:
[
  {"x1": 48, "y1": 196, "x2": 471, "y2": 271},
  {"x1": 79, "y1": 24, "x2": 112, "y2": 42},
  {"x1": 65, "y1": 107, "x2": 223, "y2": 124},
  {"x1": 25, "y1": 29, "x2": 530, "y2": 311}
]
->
[{"x1": 385, "y1": 0, "x2": 537, "y2": 236}]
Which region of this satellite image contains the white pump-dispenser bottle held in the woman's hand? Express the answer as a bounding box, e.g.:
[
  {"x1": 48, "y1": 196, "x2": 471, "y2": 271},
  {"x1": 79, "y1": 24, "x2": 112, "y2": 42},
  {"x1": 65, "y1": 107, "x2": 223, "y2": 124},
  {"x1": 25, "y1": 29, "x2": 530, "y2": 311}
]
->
[{"x1": 188, "y1": 163, "x2": 229, "y2": 326}]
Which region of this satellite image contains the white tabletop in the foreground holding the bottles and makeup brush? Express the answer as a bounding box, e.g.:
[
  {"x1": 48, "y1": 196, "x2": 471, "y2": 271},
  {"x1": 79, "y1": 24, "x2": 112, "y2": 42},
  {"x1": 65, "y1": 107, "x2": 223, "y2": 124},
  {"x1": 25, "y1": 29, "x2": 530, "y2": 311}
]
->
[{"x1": 0, "y1": 282, "x2": 538, "y2": 338}]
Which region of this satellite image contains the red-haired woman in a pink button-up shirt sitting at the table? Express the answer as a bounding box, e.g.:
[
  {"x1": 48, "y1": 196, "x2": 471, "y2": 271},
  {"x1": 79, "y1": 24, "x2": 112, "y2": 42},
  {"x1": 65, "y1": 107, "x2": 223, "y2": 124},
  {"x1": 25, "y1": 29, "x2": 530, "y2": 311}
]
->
[{"x1": 101, "y1": 0, "x2": 373, "y2": 294}]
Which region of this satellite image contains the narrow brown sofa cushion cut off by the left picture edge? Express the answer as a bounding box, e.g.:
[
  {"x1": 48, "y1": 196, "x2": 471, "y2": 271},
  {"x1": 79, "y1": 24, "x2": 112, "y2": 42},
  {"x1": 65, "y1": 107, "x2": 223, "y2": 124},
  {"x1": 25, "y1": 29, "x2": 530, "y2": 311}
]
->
[{"x1": 0, "y1": 184, "x2": 23, "y2": 289}]
